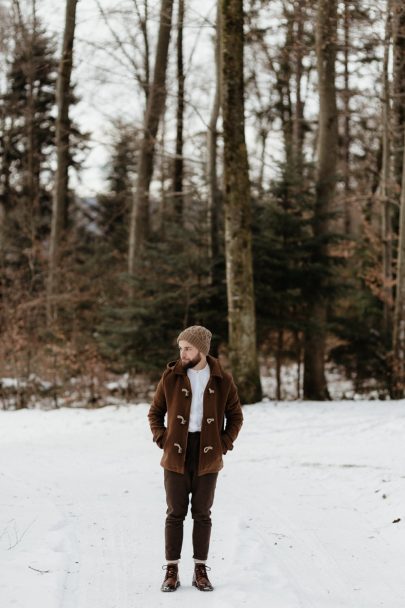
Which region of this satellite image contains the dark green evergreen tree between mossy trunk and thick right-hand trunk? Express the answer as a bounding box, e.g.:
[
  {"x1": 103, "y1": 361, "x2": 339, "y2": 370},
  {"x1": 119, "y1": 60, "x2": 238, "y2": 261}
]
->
[{"x1": 253, "y1": 163, "x2": 319, "y2": 399}]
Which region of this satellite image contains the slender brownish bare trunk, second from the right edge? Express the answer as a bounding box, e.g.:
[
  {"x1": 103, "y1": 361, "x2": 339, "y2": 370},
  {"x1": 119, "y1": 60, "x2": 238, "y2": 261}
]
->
[{"x1": 379, "y1": 0, "x2": 393, "y2": 342}]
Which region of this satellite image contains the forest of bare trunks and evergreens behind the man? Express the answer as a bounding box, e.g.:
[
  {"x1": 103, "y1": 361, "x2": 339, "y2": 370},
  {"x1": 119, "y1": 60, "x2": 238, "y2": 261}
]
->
[{"x1": 0, "y1": 0, "x2": 405, "y2": 408}]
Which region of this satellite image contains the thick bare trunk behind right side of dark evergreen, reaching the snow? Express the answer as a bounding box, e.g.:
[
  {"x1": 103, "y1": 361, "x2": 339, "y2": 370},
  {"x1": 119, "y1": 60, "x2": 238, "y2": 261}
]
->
[{"x1": 304, "y1": 0, "x2": 338, "y2": 400}]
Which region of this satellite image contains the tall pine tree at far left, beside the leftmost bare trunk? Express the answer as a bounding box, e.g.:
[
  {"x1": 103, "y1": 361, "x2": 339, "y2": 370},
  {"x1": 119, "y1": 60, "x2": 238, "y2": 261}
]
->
[{"x1": 0, "y1": 24, "x2": 57, "y2": 249}]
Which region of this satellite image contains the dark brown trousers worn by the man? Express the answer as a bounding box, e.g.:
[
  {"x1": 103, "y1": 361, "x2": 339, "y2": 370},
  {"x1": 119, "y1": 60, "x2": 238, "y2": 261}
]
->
[{"x1": 164, "y1": 433, "x2": 218, "y2": 561}]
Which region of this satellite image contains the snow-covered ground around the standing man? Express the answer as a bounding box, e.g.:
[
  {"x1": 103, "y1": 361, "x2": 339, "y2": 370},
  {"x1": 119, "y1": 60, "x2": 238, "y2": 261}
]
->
[{"x1": 0, "y1": 401, "x2": 405, "y2": 608}]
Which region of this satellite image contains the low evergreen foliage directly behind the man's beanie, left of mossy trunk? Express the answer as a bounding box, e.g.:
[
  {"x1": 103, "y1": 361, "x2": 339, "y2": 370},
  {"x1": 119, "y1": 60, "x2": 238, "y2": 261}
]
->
[{"x1": 98, "y1": 220, "x2": 226, "y2": 372}]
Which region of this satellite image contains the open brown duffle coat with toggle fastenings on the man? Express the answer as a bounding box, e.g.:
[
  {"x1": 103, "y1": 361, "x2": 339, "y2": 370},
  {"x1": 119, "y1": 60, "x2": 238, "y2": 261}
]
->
[{"x1": 148, "y1": 355, "x2": 243, "y2": 475}]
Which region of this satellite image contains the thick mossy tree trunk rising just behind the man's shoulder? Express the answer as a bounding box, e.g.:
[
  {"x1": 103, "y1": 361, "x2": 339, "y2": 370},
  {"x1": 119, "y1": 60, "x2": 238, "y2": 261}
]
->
[{"x1": 222, "y1": 0, "x2": 262, "y2": 403}]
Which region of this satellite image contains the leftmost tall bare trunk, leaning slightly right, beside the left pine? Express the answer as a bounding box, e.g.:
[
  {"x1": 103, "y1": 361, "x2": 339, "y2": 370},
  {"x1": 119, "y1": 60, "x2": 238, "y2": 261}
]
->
[{"x1": 47, "y1": 0, "x2": 78, "y2": 323}]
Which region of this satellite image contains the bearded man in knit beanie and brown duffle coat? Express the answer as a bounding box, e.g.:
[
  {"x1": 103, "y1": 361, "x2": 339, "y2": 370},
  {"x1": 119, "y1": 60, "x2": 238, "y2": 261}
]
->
[{"x1": 148, "y1": 325, "x2": 243, "y2": 591}]
